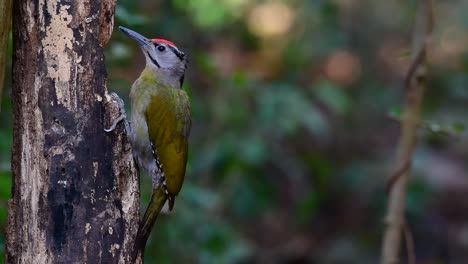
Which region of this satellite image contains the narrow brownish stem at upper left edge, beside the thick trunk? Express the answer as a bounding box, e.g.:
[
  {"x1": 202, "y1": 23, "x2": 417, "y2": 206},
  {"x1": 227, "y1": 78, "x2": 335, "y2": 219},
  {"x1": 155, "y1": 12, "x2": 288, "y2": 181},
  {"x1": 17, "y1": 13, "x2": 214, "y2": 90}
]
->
[{"x1": 0, "y1": 0, "x2": 11, "y2": 112}]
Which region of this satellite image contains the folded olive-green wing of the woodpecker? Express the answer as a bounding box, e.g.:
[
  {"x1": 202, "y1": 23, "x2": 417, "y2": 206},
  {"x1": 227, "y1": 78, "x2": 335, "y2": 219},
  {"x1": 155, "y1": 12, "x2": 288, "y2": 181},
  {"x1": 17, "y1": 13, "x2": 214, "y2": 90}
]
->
[{"x1": 146, "y1": 88, "x2": 192, "y2": 196}]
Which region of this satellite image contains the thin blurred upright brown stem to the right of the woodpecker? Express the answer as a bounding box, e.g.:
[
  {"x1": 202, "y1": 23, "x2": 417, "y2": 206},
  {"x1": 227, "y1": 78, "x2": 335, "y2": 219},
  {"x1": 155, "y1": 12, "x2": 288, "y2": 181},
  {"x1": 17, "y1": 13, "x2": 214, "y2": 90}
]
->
[{"x1": 381, "y1": 0, "x2": 434, "y2": 264}]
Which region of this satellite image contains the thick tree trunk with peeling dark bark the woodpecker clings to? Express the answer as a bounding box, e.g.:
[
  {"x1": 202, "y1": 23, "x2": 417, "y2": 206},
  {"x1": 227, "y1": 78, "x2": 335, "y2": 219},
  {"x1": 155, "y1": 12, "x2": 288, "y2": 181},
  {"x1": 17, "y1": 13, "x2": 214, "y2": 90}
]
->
[{"x1": 6, "y1": 0, "x2": 139, "y2": 264}]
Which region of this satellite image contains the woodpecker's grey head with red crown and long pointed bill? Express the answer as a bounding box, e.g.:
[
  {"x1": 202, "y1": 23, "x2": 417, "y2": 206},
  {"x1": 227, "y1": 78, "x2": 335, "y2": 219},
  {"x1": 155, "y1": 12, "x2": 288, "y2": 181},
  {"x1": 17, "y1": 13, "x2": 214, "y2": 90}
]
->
[{"x1": 119, "y1": 26, "x2": 188, "y2": 87}]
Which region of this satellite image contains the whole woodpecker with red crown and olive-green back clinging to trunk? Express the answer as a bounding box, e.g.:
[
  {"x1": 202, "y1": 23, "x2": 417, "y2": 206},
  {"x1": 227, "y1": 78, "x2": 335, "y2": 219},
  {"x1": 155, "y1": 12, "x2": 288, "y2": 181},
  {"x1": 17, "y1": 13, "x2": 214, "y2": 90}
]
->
[{"x1": 106, "y1": 26, "x2": 192, "y2": 257}]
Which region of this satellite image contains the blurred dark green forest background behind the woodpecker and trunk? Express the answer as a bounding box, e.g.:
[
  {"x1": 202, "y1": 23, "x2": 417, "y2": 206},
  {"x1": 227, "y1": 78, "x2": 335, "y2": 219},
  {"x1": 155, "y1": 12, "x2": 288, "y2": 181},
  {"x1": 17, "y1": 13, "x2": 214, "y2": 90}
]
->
[{"x1": 0, "y1": 0, "x2": 468, "y2": 264}]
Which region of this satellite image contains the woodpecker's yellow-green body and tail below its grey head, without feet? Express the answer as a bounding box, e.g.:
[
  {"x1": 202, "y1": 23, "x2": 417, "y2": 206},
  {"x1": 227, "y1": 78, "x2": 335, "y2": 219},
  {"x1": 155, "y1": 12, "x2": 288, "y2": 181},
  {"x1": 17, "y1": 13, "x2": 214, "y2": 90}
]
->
[{"x1": 130, "y1": 69, "x2": 191, "y2": 256}]
